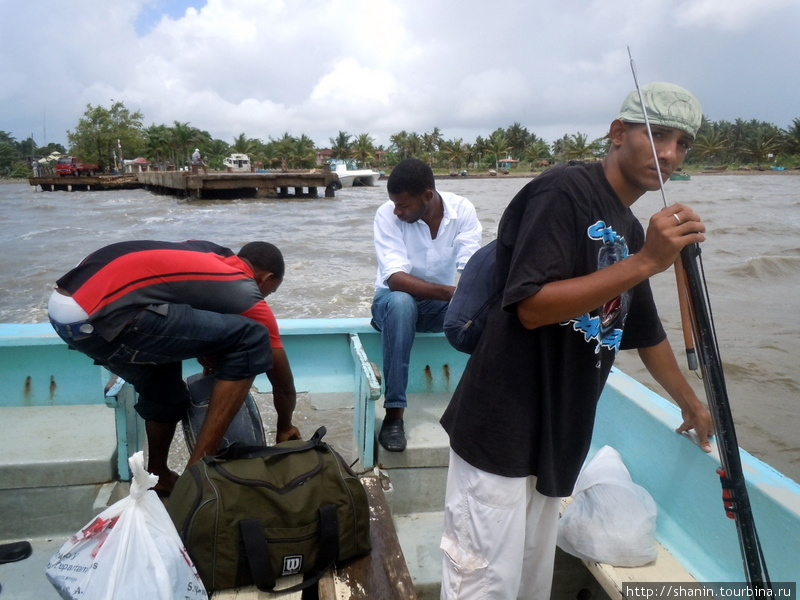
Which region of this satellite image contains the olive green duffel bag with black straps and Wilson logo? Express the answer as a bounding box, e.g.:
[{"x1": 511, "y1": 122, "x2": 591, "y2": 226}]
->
[{"x1": 168, "y1": 427, "x2": 371, "y2": 591}]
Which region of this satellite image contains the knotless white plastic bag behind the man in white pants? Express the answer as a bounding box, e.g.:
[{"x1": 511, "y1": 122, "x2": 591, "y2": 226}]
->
[{"x1": 557, "y1": 446, "x2": 657, "y2": 567}]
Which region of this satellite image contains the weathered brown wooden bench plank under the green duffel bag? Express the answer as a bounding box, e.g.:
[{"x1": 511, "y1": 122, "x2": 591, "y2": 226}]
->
[{"x1": 214, "y1": 475, "x2": 417, "y2": 600}]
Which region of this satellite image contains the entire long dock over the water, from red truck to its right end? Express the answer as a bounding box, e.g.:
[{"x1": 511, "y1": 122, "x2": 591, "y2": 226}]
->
[{"x1": 28, "y1": 171, "x2": 341, "y2": 200}]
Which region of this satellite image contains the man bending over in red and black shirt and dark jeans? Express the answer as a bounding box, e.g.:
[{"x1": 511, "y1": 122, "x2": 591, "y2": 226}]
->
[{"x1": 47, "y1": 240, "x2": 300, "y2": 495}]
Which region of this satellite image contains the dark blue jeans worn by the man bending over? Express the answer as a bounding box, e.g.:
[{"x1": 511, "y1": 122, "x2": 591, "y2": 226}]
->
[{"x1": 54, "y1": 304, "x2": 272, "y2": 423}]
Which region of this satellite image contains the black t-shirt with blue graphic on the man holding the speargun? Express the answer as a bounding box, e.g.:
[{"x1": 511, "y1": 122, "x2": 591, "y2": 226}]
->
[{"x1": 441, "y1": 162, "x2": 665, "y2": 497}]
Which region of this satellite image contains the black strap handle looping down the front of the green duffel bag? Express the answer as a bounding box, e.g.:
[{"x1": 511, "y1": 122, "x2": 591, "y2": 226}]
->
[{"x1": 239, "y1": 504, "x2": 339, "y2": 592}]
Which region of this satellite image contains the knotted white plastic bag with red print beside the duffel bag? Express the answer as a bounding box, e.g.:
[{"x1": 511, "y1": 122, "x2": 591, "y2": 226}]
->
[{"x1": 46, "y1": 452, "x2": 208, "y2": 600}]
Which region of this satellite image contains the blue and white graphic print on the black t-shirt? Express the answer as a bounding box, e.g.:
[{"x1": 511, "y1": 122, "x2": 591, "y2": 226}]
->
[{"x1": 562, "y1": 221, "x2": 630, "y2": 354}]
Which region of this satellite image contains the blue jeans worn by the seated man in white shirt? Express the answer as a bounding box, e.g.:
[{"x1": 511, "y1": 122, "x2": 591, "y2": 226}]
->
[{"x1": 372, "y1": 291, "x2": 449, "y2": 408}]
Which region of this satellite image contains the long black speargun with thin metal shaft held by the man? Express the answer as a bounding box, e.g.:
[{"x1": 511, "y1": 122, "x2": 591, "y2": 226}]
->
[{"x1": 628, "y1": 47, "x2": 771, "y2": 590}]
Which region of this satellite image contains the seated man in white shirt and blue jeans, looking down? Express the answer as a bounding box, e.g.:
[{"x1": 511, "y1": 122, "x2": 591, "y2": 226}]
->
[{"x1": 372, "y1": 158, "x2": 482, "y2": 452}]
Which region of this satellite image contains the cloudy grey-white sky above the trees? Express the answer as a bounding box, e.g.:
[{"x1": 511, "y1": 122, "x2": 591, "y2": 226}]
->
[{"x1": 0, "y1": 0, "x2": 800, "y2": 146}]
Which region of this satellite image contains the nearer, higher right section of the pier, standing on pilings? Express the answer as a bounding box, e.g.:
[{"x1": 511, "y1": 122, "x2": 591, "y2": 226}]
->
[{"x1": 136, "y1": 171, "x2": 341, "y2": 200}]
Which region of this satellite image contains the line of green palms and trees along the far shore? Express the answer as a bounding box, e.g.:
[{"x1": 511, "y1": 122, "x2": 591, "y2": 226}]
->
[{"x1": 0, "y1": 102, "x2": 800, "y2": 177}]
